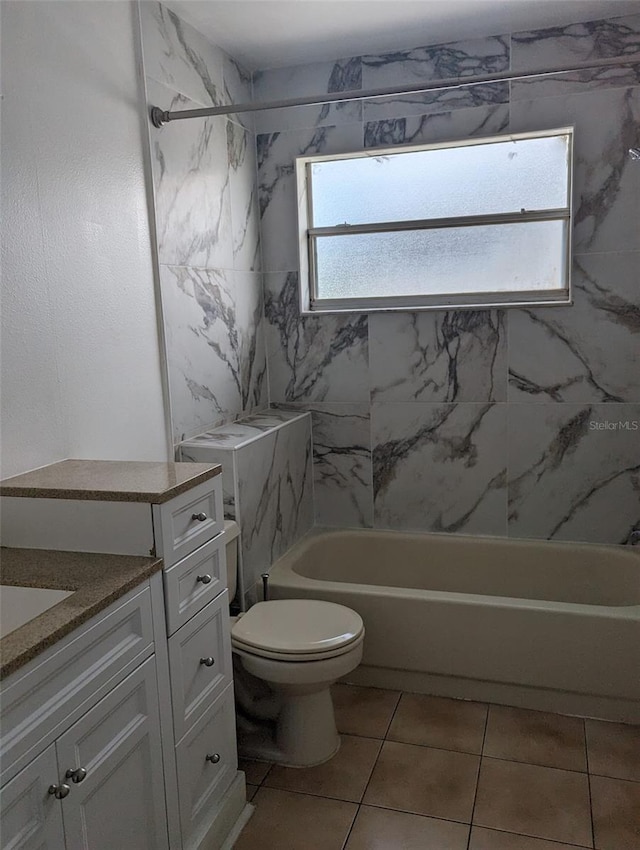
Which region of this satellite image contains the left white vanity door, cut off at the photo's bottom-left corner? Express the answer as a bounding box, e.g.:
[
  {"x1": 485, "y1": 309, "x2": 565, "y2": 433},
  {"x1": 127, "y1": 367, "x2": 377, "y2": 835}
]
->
[{"x1": 0, "y1": 744, "x2": 66, "y2": 850}]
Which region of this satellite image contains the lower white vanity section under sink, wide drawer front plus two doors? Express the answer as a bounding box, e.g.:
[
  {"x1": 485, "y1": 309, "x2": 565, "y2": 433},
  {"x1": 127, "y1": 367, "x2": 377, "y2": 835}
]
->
[{"x1": 0, "y1": 588, "x2": 169, "y2": 850}]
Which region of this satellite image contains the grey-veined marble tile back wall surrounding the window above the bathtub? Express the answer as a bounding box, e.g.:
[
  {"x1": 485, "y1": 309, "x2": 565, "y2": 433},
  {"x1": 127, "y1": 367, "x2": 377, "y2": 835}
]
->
[{"x1": 254, "y1": 15, "x2": 640, "y2": 543}]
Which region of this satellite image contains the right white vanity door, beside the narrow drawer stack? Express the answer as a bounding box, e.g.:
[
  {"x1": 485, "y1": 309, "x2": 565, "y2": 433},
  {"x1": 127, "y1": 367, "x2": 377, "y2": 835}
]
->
[{"x1": 56, "y1": 657, "x2": 168, "y2": 850}]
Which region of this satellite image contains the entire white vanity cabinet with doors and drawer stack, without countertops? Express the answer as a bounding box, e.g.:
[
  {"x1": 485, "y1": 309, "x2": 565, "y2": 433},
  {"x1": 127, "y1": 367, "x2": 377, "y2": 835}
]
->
[{"x1": 0, "y1": 461, "x2": 249, "y2": 850}]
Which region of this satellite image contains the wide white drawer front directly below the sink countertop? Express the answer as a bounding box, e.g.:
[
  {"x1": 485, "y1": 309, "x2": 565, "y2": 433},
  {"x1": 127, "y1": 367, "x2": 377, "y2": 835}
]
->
[{"x1": 0, "y1": 583, "x2": 153, "y2": 779}]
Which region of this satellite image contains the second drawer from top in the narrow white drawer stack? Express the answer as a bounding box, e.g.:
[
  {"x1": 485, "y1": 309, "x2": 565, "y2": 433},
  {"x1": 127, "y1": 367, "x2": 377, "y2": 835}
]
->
[{"x1": 164, "y1": 536, "x2": 227, "y2": 635}]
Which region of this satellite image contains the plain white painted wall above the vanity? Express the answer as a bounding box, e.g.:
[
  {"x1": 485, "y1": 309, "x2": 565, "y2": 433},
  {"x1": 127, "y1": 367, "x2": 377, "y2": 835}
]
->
[{"x1": 0, "y1": 0, "x2": 169, "y2": 476}]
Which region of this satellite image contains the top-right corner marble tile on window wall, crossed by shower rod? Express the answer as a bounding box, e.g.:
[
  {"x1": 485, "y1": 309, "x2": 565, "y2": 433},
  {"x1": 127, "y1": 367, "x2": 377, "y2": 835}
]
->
[{"x1": 511, "y1": 15, "x2": 640, "y2": 100}]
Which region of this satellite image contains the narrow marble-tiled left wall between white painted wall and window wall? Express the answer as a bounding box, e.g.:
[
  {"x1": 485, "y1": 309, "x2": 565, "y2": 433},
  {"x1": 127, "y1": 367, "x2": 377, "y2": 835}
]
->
[{"x1": 140, "y1": 0, "x2": 268, "y2": 442}]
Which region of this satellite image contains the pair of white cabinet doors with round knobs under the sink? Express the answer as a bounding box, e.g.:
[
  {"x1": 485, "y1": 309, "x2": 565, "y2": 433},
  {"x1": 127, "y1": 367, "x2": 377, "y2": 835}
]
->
[{"x1": 0, "y1": 656, "x2": 169, "y2": 850}]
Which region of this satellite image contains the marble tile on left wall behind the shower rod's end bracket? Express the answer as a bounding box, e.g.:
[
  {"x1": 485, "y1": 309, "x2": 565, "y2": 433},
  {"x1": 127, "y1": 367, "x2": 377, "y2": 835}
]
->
[{"x1": 147, "y1": 80, "x2": 233, "y2": 269}]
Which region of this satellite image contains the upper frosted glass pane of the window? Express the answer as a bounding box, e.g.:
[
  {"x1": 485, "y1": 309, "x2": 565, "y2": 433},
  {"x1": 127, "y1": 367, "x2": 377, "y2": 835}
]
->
[{"x1": 311, "y1": 135, "x2": 569, "y2": 227}]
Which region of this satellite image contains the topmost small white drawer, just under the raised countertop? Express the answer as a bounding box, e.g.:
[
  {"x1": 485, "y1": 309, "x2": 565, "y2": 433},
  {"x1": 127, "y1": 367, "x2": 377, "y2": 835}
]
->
[{"x1": 153, "y1": 475, "x2": 224, "y2": 567}]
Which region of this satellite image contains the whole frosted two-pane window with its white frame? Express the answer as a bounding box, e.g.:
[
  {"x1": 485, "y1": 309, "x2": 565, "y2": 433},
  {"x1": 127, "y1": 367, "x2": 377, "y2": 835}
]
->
[{"x1": 296, "y1": 128, "x2": 573, "y2": 313}]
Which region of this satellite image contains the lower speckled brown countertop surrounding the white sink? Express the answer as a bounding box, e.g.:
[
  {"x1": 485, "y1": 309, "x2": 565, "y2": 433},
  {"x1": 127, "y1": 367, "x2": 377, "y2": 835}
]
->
[{"x1": 0, "y1": 548, "x2": 161, "y2": 678}]
